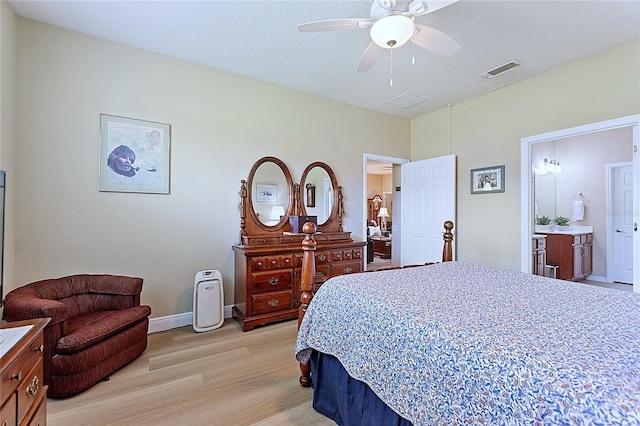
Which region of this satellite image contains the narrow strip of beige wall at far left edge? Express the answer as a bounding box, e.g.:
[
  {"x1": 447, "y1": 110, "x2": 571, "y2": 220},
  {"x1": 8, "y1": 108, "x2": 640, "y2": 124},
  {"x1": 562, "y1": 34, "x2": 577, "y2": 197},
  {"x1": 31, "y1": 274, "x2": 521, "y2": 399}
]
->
[{"x1": 0, "y1": 0, "x2": 18, "y2": 296}]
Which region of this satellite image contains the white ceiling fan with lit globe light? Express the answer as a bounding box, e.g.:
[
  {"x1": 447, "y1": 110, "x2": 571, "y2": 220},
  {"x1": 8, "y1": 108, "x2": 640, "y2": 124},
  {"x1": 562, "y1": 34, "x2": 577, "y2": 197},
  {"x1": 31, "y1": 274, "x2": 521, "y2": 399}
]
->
[{"x1": 298, "y1": 0, "x2": 460, "y2": 72}]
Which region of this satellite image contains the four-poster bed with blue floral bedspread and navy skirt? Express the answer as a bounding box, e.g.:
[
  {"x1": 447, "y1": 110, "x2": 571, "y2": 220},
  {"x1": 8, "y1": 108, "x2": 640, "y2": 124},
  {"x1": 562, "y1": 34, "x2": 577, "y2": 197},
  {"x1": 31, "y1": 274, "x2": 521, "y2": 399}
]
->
[{"x1": 295, "y1": 222, "x2": 640, "y2": 425}]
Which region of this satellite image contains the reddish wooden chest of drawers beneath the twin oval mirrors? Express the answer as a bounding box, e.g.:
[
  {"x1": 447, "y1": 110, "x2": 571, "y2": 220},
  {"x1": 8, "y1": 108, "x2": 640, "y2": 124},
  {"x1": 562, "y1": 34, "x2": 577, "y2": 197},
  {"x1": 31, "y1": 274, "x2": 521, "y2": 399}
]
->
[{"x1": 233, "y1": 236, "x2": 365, "y2": 331}]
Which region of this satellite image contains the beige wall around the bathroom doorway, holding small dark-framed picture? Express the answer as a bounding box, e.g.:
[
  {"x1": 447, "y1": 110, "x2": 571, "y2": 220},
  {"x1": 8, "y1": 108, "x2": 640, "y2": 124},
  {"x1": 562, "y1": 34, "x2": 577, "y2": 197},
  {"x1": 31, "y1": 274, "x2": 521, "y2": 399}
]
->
[{"x1": 411, "y1": 41, "x2": 640, "y2": 270}]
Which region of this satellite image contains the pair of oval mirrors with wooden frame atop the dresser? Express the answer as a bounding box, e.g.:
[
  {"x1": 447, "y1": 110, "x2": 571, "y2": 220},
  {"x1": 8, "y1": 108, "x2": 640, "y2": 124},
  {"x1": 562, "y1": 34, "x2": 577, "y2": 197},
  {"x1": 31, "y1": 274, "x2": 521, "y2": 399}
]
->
[{"x1": 240, "y1": 157, "x2": 343, "y2": 244}]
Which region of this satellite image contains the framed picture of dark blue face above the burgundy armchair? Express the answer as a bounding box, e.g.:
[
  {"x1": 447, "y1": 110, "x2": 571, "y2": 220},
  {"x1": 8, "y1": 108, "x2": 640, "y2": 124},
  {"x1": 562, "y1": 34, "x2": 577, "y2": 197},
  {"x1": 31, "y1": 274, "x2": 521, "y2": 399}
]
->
[{"x1": 100, "y1": 114, "x2": 171, "y2": 194}]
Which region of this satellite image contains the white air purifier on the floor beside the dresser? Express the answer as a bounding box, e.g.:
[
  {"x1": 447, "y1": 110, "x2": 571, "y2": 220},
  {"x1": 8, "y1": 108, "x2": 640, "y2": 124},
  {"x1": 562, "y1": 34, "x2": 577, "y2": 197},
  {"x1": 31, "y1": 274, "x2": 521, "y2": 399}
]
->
[{"x1": 193, "y1": 269, "x2": 224, "y2": 332}]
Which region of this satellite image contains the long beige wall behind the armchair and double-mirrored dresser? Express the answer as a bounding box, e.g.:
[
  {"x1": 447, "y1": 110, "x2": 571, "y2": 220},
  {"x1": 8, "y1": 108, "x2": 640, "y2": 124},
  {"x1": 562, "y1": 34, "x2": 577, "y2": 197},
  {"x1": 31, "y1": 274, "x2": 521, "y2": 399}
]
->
[{"x1": 5, "y1": 18, "x2": 410, "y2": 317}]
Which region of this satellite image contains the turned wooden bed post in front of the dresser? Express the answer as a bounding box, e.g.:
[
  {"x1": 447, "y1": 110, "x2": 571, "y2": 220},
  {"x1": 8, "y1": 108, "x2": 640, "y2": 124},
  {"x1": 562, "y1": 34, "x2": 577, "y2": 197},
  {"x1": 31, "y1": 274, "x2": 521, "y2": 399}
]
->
[{"x1": 298, "y1": 222, "x2": 316, "y2": 388}]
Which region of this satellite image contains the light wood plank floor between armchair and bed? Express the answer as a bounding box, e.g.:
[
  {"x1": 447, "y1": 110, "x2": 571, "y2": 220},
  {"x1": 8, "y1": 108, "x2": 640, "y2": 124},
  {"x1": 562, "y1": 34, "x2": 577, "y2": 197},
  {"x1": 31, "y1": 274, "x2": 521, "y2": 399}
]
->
[{"x1": 47, "y1": 319, "x2": 335, "y2": 426}]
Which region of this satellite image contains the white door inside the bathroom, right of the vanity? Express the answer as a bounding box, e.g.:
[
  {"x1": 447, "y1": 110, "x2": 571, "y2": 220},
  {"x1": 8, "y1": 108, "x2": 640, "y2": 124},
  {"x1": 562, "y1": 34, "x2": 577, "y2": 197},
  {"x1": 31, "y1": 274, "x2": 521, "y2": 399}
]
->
[{"x1": 610, "y1": 165, "x2": 633, "y2": 284}]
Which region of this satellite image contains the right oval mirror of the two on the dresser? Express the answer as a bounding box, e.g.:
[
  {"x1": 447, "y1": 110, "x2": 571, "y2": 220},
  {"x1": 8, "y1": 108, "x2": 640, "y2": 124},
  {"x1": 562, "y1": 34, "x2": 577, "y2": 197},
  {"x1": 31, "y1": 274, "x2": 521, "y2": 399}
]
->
[{"x1": 300, "y1": 162, "x2": 338, "y2": 228}]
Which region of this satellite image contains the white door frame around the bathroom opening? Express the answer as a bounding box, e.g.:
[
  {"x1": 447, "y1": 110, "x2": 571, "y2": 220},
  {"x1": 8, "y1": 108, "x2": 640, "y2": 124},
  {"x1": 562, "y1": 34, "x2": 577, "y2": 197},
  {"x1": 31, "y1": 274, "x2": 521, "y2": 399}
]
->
[{"x1": 520, "y1": 115, "x2": 640, "y2": 292}]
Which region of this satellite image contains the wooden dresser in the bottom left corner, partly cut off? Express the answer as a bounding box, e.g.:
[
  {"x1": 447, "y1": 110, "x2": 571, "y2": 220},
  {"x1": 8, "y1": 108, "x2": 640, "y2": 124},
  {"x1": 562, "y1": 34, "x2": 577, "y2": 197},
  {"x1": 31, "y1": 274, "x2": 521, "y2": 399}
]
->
[{"x1": 0, "y1": 318, "x2": 49, "y2": 426}]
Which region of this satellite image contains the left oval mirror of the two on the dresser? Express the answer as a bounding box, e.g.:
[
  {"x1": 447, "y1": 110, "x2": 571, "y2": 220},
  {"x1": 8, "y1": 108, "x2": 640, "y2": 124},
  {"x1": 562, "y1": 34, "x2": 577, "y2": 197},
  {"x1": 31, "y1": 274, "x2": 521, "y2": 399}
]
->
[{"x1": 247, "y1": 157, "x2": 293, "y2": 228}]
